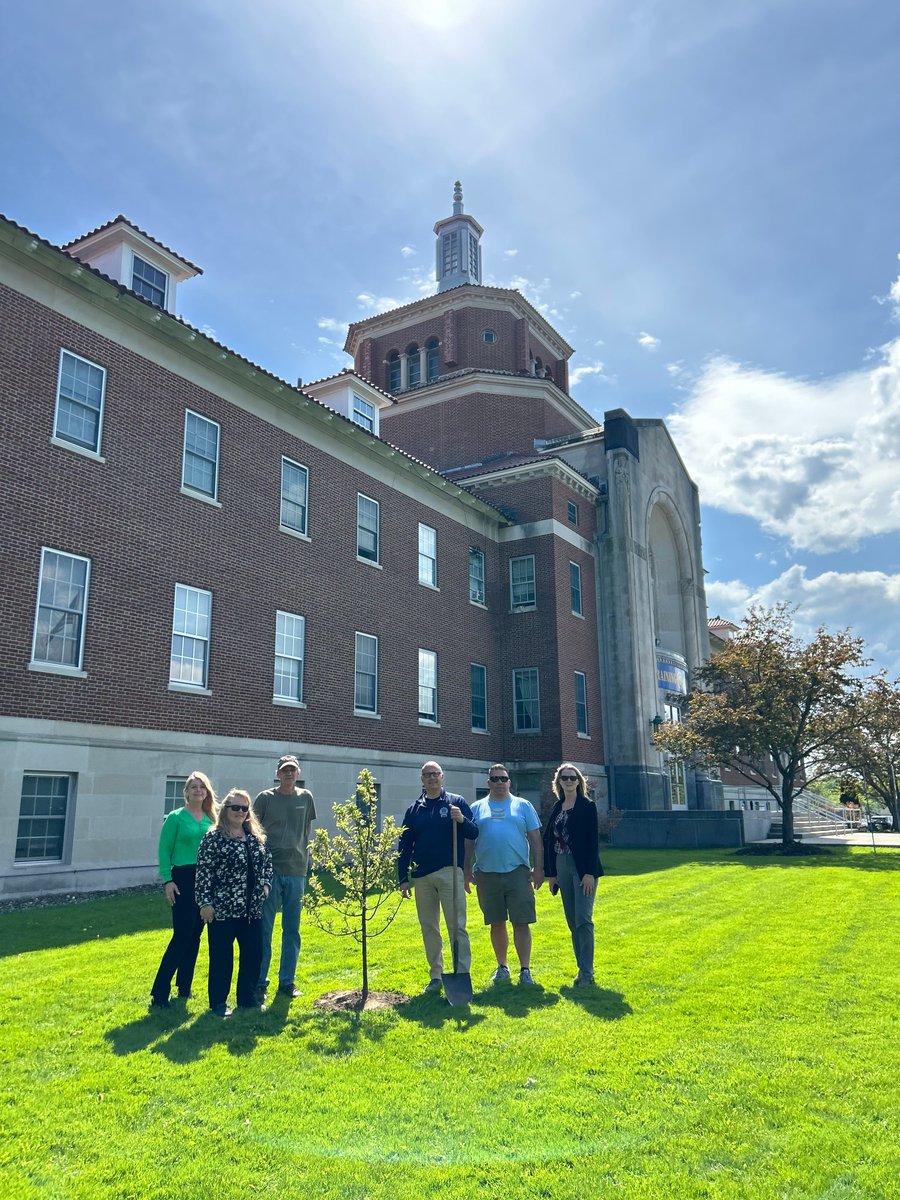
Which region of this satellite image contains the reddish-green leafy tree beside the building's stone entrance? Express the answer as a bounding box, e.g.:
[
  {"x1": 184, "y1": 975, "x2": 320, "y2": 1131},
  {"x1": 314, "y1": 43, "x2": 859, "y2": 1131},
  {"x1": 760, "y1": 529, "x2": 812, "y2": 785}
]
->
[{"x1": 654, "y1": 604, "x2": 864, "y2": 845}]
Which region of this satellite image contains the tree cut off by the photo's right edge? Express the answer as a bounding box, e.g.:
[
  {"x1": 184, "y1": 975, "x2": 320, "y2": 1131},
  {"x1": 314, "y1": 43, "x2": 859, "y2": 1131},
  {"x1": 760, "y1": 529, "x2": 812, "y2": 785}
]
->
[{"x1": 839, "y1": 674, "x2": 900, "y2": 829}]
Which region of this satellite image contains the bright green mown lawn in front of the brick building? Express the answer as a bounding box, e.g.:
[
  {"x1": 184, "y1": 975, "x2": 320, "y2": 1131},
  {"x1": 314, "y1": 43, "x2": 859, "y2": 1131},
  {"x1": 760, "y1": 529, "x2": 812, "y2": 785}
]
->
[{"x1": 0, "y1": 850, "x2": 900, "y2": 1200}]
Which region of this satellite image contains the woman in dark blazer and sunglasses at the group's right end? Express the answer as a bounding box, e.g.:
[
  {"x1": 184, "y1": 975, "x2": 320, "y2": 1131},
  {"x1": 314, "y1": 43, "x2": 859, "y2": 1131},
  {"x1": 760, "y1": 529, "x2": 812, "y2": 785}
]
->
[{"x1": 544, "y1": 762, "x2": 604, "y2": 988}]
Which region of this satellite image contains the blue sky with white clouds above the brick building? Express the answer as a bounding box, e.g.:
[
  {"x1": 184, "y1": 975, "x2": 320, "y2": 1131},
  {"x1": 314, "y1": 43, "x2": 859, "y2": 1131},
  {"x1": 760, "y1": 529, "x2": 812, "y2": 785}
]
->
[{"x1": 0, "y1": 0, "x2": 900, "y2": 678}]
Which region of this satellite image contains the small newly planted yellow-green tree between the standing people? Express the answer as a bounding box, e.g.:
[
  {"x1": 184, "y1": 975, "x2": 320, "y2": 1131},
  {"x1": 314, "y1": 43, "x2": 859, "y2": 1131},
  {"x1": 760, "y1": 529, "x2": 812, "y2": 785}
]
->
[{"x1": 305, "y1": 770, "x2": 402, "y2": 1010}]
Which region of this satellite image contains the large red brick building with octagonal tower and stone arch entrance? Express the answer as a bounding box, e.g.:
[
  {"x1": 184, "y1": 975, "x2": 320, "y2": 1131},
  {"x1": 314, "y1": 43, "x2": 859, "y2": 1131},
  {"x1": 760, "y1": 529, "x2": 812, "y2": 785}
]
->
[{"x1": 0, "y1": 187, "x2": 715, "y2": 894}]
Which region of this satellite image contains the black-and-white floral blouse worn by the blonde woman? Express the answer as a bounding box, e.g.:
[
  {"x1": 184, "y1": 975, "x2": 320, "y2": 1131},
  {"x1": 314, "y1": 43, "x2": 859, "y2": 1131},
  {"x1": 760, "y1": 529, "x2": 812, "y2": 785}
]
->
[{"x1": 194, "y1": 829, "x2": 272, "y2": 920}]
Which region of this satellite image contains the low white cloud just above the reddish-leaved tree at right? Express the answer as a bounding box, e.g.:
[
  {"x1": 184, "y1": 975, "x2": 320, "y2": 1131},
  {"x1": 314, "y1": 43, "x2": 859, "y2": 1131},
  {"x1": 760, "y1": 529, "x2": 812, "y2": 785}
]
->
[{"x1": 706, "y1": 564, "x2": 900, "y2": 678}]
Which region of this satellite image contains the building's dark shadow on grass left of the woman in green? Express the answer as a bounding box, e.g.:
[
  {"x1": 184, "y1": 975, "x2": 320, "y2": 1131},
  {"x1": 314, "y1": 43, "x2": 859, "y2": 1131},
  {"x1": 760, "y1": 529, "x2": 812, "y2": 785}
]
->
[{"x1": 0, "y1": 889, "x2": 165, "y2": 958}]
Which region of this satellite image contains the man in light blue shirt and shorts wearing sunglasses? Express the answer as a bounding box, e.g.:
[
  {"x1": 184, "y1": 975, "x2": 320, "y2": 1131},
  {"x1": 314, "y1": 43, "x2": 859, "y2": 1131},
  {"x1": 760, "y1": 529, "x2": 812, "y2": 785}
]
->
[{"x1": 466, "y1": 763, "x2": 544, "y2": 985}]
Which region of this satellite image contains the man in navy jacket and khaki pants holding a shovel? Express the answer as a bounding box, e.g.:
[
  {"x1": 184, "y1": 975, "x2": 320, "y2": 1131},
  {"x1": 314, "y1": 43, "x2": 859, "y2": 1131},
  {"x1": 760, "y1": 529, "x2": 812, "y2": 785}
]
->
[{"x1": 397, "y1": 762, "x2": 478, "y2": 992}]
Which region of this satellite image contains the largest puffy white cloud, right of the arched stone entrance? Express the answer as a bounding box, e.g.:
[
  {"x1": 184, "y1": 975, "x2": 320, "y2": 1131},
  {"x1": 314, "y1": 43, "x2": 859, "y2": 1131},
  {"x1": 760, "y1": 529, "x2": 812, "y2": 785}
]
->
[{"x1": 667, "y1": 338, "x2": 900, "y2": 553}]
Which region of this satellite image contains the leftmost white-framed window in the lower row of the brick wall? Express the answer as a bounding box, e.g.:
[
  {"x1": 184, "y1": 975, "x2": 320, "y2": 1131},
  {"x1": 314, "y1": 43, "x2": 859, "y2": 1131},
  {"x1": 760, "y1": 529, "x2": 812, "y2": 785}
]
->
[{"x1": 31, "y1": 546, "x2": 91, "y2": 671}]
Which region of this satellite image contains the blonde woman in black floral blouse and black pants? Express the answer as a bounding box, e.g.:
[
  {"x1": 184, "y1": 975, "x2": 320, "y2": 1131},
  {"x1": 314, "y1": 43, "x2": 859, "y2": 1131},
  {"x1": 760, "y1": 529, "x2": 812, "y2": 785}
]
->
[{"x1": 196, "y1": 788, "x2": 272, "y2": 1016}]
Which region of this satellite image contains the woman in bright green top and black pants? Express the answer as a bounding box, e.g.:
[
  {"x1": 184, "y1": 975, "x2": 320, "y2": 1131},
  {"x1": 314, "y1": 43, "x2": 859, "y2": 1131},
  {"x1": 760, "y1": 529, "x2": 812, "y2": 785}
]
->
[{"x1": 150, "y1": 770, "x2": 216, "y2": 1008}]
